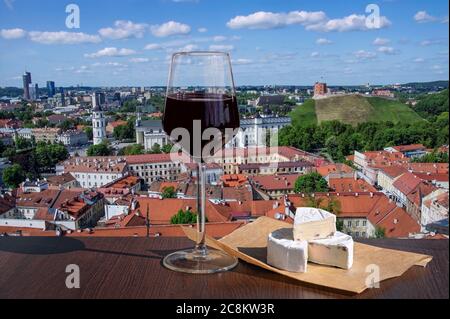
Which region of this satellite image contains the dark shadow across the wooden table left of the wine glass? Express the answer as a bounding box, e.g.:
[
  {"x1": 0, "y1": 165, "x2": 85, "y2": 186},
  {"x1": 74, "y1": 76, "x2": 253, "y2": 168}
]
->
[{"x1": 0, "y1": 237, "x2": 161, "y2": 259}]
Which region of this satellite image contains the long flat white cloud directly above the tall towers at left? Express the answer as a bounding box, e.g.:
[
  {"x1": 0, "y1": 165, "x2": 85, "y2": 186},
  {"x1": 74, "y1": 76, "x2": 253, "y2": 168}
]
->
[{"x1": 29, "y1": 31, "x2": 102, "y2": 44}]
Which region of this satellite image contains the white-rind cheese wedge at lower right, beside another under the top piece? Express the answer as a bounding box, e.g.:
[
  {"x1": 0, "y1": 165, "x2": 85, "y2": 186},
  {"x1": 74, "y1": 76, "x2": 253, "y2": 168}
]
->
[{"x1": 308, "y1": 232, "x2": 354, "y2": 269}]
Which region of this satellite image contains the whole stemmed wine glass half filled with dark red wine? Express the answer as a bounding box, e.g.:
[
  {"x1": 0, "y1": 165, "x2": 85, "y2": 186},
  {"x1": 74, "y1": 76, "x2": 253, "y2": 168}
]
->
[{"x1": 163, "y1": 52, "x2": 240, "y2": 274}]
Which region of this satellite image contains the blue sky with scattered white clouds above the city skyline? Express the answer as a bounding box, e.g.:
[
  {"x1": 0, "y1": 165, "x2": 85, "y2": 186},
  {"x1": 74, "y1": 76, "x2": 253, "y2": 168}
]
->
[{"x1": 0, "y1": 0, "x2": 449, "y2": 86}]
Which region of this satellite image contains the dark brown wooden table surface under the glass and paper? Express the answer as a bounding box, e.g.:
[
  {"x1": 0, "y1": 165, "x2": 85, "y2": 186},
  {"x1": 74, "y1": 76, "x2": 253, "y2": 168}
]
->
[{"x1": 0, "y1": 237, "x2": 449, "y2": 299}]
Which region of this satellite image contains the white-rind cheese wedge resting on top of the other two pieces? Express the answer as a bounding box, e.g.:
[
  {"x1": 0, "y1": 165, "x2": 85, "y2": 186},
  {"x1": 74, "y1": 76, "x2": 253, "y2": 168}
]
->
[{"x1": 294, "y1": 207, "x2": 336, "y2": 241}]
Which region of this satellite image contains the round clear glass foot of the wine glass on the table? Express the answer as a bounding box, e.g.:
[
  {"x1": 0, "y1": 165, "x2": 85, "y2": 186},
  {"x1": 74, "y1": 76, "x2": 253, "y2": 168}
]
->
[{"x1": 163, "y1": 249, "x2": 238, "y2": 274}]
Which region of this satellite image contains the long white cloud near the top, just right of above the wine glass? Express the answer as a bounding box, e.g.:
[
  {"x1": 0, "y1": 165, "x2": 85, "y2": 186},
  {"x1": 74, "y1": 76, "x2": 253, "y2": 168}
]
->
[{"x1": 227, "y1": 11, "x2": 326, "y2": 29}]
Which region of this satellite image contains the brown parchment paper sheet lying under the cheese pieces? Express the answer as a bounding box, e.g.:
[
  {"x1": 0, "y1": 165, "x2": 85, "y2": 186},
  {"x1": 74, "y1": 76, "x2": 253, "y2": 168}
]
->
[{"x1": 183, "y1": 217, "x2": 432, "y2": 294}]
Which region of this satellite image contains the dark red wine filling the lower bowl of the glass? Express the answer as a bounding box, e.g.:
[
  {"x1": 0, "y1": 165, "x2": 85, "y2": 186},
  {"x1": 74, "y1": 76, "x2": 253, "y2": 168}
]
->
[{"x1": 163, "y1": 93, "x2": 240, "y2": 161}]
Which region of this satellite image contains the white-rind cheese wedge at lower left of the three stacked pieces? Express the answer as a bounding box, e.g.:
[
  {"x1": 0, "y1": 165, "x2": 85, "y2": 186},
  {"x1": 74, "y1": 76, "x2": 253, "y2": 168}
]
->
[{"x1": 267, "y1": 228, "x2": 308, "y2": 273}]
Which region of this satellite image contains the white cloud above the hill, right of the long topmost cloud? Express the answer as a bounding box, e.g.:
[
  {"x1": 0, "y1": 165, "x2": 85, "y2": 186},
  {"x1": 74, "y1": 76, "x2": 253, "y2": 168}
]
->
[{"x1": 306, "y1": 14, "x2": 392, "y2": 32}]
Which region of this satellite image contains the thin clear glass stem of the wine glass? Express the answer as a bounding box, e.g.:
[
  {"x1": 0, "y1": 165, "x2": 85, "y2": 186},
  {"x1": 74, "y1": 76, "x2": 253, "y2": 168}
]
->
[{"x1": 195, "y1": 163, "x2": 208, "y2": 256}]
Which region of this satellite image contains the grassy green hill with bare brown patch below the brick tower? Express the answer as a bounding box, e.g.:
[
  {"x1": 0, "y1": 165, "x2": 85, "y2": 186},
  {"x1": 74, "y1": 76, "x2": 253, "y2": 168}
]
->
[{"x1": 290, "y1": 95, "x2": 423, "y2": 126}]
